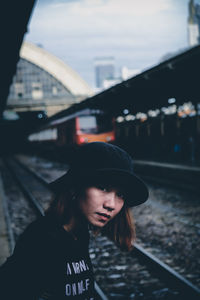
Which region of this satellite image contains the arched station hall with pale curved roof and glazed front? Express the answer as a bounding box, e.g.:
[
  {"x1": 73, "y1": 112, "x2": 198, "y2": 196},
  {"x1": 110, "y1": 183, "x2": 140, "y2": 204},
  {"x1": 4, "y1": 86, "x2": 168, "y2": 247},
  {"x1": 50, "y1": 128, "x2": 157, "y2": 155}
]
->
[{"x1": 7, "y1": 42, "x2": 93, "y2": 116}]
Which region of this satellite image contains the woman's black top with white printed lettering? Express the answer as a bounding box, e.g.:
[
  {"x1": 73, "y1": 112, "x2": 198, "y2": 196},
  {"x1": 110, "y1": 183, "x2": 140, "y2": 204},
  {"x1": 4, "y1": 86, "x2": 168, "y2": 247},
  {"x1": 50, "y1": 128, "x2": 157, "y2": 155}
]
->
[{"x1": 0, "y1": 216, "x2": 95, "y2": 300}]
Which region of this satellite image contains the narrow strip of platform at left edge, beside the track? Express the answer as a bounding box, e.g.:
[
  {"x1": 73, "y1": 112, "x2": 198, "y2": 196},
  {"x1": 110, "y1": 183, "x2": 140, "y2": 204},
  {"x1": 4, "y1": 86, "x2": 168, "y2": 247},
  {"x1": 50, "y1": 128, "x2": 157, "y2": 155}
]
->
[{"x1": 0, "y1": 166, "x2": 10, "y2": 265}]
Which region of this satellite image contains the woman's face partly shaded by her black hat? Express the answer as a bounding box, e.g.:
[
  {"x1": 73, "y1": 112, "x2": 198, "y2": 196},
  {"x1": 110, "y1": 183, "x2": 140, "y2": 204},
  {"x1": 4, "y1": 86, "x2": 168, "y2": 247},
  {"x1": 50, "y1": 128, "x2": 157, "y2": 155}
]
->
[{"x1": 80, "y1": 186, "x2": 124, "y2": 227}]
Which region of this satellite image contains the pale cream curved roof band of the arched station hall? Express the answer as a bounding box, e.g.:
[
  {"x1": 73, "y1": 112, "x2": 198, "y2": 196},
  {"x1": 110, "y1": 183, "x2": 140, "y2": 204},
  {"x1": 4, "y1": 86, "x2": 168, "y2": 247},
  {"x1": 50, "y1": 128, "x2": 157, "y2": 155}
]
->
[{"x1": 20, "y1": 42, "x2": 93, "y2": 96}]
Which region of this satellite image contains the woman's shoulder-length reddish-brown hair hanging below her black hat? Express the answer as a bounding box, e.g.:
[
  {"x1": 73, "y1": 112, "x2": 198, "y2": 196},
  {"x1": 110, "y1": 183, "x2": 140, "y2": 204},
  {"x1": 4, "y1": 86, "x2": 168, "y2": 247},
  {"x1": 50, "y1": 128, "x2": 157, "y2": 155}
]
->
[{"x1": 46, "y1": 187, "x2": 135, "y2": 251}]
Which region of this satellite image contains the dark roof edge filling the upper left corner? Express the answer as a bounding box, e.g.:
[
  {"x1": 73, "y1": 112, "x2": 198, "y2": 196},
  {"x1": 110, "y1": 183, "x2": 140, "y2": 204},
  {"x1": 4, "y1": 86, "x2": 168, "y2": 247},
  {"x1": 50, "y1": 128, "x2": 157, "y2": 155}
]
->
[{"x1": 0, "y1": 0, "x2": 35, "y2": 118}]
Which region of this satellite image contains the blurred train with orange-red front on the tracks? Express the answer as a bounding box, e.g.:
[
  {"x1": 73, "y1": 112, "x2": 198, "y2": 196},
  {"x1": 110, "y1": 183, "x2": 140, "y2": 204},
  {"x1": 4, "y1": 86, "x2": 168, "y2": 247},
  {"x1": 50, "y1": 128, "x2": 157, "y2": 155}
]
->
[{"x1": 28, "y1": 109, "x2": 115, "y2": 152}]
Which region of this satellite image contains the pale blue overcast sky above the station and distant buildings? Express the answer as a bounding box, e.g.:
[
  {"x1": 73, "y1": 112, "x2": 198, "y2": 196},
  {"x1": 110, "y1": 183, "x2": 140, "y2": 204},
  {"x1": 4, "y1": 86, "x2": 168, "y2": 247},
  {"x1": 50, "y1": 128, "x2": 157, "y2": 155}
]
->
[{"x1": 25, "y1": 0, "x2": 200, "y2": 87}]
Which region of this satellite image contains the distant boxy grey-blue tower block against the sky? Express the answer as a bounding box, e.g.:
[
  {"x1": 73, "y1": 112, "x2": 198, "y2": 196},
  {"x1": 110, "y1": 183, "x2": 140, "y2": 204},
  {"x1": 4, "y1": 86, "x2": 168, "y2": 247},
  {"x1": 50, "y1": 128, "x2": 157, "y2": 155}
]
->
[{"x1": 94, "y1": 57, "x2": 115, "y2": 89}]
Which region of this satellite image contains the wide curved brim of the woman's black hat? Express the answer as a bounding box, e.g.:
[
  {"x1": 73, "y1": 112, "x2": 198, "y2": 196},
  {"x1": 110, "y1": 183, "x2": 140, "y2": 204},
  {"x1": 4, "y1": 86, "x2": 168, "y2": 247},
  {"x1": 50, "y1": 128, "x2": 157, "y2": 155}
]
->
[{"x1": 50, "y1": 169, "x2": 149, "y2": 207}]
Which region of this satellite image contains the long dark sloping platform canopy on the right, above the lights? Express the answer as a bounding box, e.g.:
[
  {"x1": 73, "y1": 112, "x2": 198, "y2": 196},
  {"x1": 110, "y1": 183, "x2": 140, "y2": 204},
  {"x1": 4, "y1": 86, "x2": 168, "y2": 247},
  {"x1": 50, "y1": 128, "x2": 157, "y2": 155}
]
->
[{"x1": 48, "y1": 46, "x2": 200, "y2": 118}]
